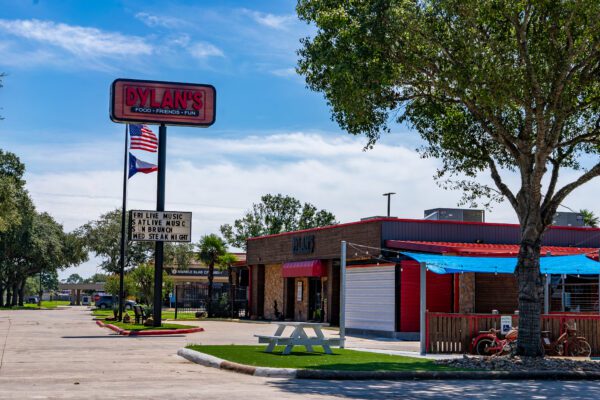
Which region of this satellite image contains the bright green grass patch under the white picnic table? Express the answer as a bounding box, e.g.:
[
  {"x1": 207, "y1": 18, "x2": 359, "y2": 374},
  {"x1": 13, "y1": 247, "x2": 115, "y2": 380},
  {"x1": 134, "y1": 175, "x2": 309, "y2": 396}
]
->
[{"x1": 187, "y1": 345, "x2": 456, "y2": 371}]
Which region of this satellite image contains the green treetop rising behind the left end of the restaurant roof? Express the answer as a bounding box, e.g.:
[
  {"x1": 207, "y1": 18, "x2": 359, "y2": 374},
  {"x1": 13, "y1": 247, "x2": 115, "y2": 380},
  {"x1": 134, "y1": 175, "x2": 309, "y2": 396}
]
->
[{"x1": 221, "y1": 194, "x2": 337, "y2": 249}]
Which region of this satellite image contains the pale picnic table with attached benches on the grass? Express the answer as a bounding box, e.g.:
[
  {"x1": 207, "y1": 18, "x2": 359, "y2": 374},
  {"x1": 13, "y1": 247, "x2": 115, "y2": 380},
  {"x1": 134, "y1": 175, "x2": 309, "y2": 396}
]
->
[{"x1": 254, "y1": 321, "x2": 340, "y2": 355}]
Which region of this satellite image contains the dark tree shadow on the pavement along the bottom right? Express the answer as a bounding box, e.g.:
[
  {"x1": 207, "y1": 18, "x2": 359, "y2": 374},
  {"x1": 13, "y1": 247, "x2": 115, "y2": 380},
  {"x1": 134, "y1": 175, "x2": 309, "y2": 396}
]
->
[{"x1": 268, "y1": 379, "x2": 600, "y2": 399}]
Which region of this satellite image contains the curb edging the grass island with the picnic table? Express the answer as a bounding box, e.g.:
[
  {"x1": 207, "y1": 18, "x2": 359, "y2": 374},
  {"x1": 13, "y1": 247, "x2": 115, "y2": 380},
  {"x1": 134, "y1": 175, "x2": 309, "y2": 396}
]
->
[{"x1": 177, "y1": 348, "x2": 600, "y2": 381}]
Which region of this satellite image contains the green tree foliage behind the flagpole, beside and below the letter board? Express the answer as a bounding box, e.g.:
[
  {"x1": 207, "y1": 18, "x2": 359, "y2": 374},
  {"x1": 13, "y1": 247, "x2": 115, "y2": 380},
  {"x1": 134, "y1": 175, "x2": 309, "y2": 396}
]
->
[{"x1": 77, "y1": 209, "x2": 153, "y2": 273}]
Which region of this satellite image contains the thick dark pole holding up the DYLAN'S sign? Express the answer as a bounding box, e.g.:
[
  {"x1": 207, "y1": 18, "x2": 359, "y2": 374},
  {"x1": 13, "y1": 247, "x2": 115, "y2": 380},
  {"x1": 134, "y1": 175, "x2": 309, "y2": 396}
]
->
[{"x1": 153, "y1": 124, "x2": 167, "y2": 326}]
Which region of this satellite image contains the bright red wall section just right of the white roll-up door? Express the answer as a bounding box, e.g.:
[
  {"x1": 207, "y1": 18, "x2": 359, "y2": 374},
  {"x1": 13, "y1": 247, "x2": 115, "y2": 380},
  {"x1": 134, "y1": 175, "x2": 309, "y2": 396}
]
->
[{"x1": 398, "y1": 261, "x2": 453, "y2": 332}]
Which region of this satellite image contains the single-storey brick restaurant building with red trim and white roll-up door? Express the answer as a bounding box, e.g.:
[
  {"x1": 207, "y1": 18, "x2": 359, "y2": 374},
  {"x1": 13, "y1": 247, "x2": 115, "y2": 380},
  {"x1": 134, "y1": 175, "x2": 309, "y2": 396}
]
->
[{"x1": 246, "y1": 217, "x2": 600, "y2": 337}]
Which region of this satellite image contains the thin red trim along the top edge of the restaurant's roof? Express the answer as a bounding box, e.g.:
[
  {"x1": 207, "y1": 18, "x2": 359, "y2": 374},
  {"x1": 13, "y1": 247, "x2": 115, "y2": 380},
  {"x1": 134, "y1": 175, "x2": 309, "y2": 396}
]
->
[{"x1": 247, "y1": 217, "x2": 600, "y2": 241}]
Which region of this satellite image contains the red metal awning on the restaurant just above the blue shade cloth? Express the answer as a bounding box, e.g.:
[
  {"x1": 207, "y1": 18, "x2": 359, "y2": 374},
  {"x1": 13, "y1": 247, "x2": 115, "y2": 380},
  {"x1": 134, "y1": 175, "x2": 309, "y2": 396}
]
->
[{"x1": 385, "y1": 240, "x2": 599, "y2": 258}]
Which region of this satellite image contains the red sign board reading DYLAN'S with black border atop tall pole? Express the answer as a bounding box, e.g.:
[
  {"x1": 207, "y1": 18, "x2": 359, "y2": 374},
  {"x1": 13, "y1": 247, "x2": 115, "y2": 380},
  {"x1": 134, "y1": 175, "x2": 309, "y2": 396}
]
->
[{"x1": 110, "y1": 79, "x2": 217, "y2": 126}]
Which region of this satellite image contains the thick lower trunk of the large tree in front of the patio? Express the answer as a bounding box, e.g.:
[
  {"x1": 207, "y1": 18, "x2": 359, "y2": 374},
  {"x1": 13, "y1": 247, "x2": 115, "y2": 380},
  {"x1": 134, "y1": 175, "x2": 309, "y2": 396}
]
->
[{"x1": 516, "y1": 235, "x2": 543, "y2": 357}]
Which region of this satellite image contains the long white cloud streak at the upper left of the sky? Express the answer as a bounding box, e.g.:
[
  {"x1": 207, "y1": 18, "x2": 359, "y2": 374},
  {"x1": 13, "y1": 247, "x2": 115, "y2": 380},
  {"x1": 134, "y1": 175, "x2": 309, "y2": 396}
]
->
[{"x1": 0, "y1": 19, "x2": 153, "y2": 57}]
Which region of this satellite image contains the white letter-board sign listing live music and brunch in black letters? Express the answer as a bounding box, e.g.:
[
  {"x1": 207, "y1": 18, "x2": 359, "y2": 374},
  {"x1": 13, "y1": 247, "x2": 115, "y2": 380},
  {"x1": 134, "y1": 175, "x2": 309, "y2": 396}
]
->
[{"x1": 129, "y1": 210, "x2": 192, "y2": 242}]
